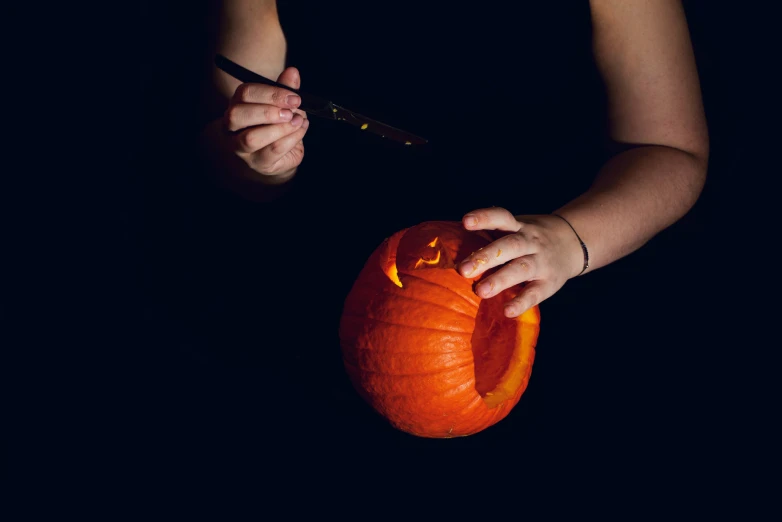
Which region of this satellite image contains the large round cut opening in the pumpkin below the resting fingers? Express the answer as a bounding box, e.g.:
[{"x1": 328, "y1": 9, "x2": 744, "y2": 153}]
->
[{"x1": 472, "y1": 293, "x2": 534, "y2": 408}]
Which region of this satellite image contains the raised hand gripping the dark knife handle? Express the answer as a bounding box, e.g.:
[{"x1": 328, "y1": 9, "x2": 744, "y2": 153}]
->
[{"x1": 223, "y1": 67, "x2": 309, "y2": 183}]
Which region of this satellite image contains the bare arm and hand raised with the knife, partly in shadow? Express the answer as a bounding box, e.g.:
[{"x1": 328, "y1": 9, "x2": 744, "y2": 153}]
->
[{"x1": 201, "y1": 0, "x2": 307, "y2": 201}]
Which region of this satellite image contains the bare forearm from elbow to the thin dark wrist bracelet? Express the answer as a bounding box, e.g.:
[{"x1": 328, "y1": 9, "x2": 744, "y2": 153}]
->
[{"x1": 557, "y1": 142, "x2": 707, "y2": 271}]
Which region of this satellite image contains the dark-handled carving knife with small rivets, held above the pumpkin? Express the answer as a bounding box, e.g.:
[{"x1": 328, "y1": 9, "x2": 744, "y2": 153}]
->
[{"x1": 215, "y1": 54, "x2": 428, "y2": 145}]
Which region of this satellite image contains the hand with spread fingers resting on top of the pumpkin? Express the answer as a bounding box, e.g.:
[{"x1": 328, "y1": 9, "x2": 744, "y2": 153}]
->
[{"x1": 459, "y1": 208, "x2": 584, "y2": 317}]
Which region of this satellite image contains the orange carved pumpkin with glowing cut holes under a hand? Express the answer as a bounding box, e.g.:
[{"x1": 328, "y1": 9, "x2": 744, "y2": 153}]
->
[{"x1": 339, "y1": 217, "x2": 540, "y2": 438}]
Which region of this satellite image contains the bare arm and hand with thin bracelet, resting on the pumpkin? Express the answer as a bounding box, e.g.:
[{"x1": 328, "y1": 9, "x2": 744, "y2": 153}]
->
[{"x1": 459, "y1": 0, "x2": 709, "y2": 317}]
